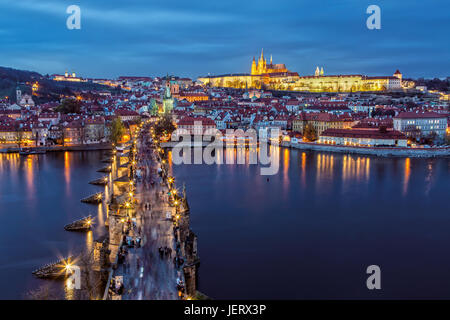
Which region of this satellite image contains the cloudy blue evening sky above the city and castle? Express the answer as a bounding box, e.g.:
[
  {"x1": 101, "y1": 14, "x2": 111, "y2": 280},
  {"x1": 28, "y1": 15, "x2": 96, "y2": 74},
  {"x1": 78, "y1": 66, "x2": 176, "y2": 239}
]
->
[{"x1": 0, "y1": 0, "x2": 450, "y2": 78}]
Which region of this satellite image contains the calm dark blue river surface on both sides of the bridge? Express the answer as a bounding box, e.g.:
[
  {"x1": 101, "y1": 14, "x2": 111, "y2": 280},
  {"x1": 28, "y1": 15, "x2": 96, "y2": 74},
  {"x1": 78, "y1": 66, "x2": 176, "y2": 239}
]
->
[{"x1": 0, "y1": 149, "x2": 450, "y2": 299}]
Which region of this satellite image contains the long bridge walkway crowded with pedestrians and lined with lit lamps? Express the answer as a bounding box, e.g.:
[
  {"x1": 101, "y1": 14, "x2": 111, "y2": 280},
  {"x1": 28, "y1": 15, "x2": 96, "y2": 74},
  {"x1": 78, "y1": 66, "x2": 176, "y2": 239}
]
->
[{"x1": 106, "y1": 120, "x2": 198, "y2": 300}]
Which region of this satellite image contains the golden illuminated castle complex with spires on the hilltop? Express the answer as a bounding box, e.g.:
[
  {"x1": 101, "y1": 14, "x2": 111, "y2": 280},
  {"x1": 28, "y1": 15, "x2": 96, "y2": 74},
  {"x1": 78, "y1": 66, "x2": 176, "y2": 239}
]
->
[{"x1": 198, "y1": 52, "x2": 403, "y2": 92}]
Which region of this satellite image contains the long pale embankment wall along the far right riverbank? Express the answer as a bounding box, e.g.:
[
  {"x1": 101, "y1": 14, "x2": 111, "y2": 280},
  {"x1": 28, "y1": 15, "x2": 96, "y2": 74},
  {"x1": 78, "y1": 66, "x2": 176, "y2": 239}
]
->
[{"x1": 281, "y1": 142, "x2": 450, "y2": 158}]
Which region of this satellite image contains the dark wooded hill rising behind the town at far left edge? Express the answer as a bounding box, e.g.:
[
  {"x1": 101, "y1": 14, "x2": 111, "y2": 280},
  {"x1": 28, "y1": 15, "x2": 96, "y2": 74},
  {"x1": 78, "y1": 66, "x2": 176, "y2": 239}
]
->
[{"x1": 0, "y1": 67, "x2": 117, "y2": 103}]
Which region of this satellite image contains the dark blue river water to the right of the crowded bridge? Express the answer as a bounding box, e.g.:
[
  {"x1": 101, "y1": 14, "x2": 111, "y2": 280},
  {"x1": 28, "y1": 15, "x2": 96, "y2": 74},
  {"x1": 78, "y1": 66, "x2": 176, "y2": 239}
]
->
[{"x1": 173, "y1": 149, "x2": 450, "y2": 299}]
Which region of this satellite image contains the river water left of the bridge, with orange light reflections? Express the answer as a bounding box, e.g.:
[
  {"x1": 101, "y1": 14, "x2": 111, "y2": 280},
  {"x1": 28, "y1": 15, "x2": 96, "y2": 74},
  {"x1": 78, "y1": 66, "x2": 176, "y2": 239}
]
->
[{"x1": 0, "y1": 151, "x2": 107, "y2": 299}]
